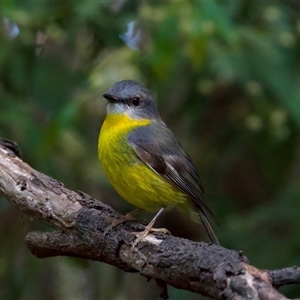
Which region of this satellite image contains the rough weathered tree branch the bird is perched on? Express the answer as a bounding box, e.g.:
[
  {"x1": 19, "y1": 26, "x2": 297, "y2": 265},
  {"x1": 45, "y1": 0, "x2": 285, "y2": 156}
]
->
[{"x1": 0, "y1": 139, "x2": 300, "y2": 300}]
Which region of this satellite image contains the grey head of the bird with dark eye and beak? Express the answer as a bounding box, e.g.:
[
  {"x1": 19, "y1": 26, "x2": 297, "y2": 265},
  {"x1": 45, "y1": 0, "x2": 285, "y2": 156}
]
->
[{"x1": 103, "y1": 80, "x2": 160, "y2": 120}]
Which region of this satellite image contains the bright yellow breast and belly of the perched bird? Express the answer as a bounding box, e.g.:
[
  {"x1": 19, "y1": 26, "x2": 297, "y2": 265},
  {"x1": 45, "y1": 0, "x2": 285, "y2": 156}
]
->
[{"x1": 98, "y1": 114, "x2": 186, "y2": 211}]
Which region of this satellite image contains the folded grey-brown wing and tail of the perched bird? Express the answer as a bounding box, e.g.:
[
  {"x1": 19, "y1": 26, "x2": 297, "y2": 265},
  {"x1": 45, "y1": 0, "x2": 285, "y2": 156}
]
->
[{"x1": 128, "y1": 125, "x2": 219, "y2": 244}]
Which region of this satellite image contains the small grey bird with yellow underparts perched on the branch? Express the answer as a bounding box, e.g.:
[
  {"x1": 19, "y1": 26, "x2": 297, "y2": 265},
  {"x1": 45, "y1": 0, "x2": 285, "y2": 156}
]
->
[{"x1": 98, "y1": 80, "x2": 219, "y2": 246}]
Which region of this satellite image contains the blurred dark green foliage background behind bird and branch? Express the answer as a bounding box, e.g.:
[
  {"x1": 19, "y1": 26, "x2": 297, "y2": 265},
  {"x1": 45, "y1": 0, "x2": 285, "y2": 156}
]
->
[{"x1": 0, "y1": 0, "x2": 300, "y2": 300}]
